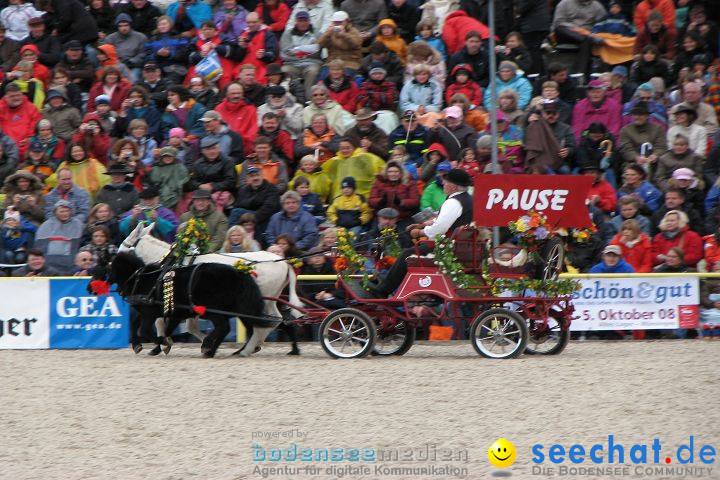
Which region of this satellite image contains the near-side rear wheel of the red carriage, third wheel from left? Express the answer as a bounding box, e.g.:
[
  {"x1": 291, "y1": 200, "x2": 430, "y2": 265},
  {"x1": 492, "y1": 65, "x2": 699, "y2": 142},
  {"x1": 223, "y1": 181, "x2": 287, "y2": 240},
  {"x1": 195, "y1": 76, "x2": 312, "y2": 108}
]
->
[{"x1": 470, "y1": 308, "x2": 528, "y2": 358}]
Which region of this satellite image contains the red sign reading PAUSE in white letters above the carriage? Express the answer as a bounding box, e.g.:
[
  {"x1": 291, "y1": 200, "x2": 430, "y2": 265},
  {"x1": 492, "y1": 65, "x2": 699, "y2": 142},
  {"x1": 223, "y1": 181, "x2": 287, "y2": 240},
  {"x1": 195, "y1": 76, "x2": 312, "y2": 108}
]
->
[{"x1": 473, "y1": 175, "x2": 593, "y2": 228}]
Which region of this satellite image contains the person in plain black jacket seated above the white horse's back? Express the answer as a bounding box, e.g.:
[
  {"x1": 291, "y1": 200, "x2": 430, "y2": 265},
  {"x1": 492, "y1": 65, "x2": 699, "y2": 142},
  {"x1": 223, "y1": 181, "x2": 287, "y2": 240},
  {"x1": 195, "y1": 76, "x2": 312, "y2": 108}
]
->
[{"x1": 230, "y1": 166, "x2": 280, "y2": 235}]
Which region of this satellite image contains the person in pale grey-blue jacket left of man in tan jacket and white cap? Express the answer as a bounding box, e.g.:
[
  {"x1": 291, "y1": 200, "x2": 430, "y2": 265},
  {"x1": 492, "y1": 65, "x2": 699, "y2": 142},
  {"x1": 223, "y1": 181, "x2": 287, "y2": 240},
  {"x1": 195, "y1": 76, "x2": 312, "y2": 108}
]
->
[{"x1": 280, "y1": 9, "x2": 322, "y2": 98}]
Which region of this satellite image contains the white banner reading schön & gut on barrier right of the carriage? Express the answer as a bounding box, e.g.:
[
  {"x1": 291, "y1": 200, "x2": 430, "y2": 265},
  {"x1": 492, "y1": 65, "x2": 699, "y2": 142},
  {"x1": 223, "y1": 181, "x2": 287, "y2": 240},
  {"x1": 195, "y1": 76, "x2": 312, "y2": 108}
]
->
[{"x1": 570, "y1": 277, "x2": 700, "y2": 331}]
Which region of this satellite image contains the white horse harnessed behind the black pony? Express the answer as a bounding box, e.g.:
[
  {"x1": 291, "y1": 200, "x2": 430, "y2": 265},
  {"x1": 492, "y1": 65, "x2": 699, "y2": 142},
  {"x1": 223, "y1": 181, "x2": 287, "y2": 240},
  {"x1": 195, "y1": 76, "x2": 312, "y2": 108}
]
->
[{"x1": 118, "y1": 223, "x2": 304, "y2": 357}]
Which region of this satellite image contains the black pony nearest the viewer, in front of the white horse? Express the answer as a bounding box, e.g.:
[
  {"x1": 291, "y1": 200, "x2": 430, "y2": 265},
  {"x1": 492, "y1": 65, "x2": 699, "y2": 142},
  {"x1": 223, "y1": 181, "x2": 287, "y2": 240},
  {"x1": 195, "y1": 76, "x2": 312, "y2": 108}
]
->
[{"x1": 91, "y1": 253, "x2": 280, "y2": 358}]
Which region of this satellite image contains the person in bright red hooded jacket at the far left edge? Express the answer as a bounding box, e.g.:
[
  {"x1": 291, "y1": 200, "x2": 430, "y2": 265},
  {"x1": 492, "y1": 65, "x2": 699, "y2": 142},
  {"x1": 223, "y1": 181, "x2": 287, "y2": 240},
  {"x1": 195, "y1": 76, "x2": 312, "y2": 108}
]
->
[{"x1": 0, "y1": 83, "x2": 42, "y2": 157}]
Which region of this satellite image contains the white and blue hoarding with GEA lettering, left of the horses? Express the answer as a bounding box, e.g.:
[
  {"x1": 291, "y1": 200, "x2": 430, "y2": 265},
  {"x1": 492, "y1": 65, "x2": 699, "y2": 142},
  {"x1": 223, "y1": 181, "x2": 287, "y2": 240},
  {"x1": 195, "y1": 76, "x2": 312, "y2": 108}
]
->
[{"x1": 0, "y1": 278, "x2": 130, "y2": 349}]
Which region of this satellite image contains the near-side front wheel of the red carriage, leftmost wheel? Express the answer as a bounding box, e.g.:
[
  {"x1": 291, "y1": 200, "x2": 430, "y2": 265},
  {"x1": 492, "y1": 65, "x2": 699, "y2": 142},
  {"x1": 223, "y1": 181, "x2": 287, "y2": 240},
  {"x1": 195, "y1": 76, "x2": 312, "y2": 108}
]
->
[{"x1": 320, "y1": 308, "x2": 376, "y2": 358}]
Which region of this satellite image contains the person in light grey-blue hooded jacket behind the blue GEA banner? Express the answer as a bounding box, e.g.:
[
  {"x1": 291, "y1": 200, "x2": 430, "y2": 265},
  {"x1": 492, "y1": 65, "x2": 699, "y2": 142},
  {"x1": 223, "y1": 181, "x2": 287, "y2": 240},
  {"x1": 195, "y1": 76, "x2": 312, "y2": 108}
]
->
[{"x1": 35, "y1": 200, "x2": 85, "y2": 274}]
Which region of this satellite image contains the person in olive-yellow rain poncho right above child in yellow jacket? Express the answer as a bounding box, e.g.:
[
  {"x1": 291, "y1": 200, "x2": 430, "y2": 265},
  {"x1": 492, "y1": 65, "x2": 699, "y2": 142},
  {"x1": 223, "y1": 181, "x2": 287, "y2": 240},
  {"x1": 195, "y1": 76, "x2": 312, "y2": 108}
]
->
[{"x1": 322, "y1": 138, "x2": 385, "y2": 201}]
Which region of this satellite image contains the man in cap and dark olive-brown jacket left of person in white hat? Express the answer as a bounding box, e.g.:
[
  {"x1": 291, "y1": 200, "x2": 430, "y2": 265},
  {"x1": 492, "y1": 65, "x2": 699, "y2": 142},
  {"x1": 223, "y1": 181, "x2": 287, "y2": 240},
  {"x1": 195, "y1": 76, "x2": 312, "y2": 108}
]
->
[{"x1": 618, "y1": 102, "x2": 668, "y2": 167}]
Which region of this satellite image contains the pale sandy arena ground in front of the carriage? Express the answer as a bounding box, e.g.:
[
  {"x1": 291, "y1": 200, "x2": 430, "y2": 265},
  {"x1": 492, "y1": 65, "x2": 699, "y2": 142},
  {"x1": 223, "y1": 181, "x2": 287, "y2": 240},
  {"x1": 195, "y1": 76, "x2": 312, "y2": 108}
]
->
[{"x1": 0, "y1": 340, "x2": 720, "y2": 480}]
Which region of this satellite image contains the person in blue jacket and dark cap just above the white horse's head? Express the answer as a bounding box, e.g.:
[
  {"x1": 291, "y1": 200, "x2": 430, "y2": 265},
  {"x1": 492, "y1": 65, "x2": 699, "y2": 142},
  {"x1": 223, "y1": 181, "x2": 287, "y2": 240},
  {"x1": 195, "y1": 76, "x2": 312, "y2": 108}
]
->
[{"x1": 120, "y1": 187, "x2": 178, "y2": 243}]
